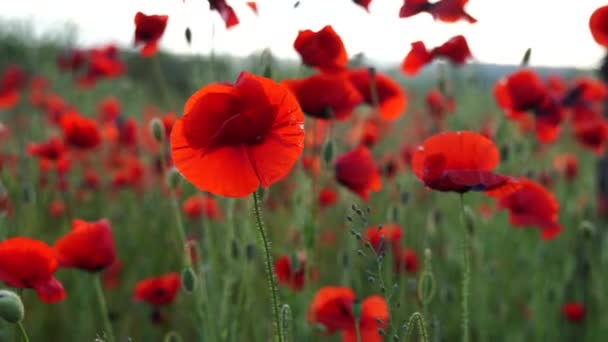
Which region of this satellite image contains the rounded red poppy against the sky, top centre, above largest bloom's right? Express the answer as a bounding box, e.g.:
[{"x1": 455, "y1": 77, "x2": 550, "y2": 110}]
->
[{"x1": 293, "y1": 25, "x2": 348, "y2": 71}]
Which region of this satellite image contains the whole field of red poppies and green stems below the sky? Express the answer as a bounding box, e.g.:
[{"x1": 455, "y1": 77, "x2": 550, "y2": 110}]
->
[{"x1": 0, "y1": 0, "x2": 608, "y2": 342}]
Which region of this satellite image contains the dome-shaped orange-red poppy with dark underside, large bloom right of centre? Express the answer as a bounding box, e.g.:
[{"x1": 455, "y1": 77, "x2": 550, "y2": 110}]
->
[{"x1": 412, "y1": 131, "x2": 517, "y2": 194}]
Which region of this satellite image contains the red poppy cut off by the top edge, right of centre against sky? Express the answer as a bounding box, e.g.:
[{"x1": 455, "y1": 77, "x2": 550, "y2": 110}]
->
[{"x1": 399, "y1": 0, "x2": 477, "y2": 24}]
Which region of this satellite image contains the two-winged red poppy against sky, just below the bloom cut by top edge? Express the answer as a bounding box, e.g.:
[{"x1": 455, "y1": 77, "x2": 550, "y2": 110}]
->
[{"x1": 401, "y1": 36, "x2": 472, "y2": 76}]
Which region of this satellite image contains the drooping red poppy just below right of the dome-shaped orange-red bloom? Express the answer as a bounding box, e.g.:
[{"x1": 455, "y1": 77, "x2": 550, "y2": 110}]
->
[{"x1": 495, "y1": 179, "x2": 562, "y2": 240}]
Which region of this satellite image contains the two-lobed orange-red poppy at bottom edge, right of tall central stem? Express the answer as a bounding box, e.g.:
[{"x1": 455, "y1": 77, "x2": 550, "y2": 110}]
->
[{"x1": 308, "y1": 286, "x2": 388, "y2": 342}]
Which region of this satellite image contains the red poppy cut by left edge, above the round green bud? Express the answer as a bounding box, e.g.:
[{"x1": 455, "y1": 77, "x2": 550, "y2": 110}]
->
[{"x1": 0, "y1": 237, "x2": 66, "y2": 303}]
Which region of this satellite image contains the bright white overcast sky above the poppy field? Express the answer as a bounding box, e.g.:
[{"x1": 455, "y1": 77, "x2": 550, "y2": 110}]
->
[{"x1": 0, "y1": 0, "x2": 606, "y2": 67}]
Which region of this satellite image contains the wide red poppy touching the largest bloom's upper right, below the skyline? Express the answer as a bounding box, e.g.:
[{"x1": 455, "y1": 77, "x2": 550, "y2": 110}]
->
[{"x1": 283, "y1": 74, "x2": 363, "y2": 120}]
